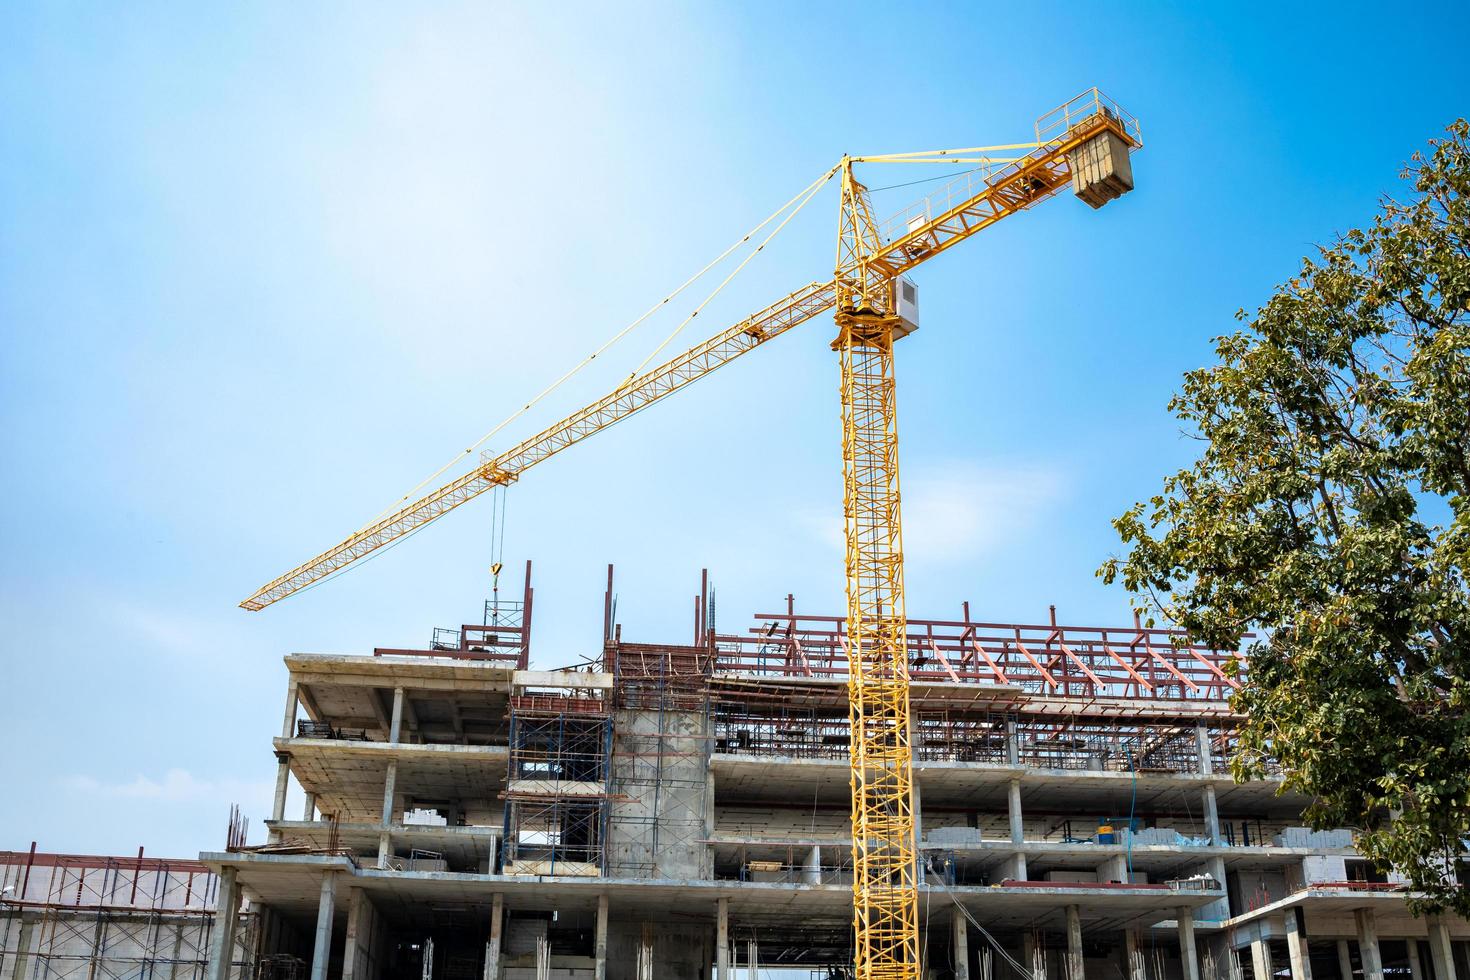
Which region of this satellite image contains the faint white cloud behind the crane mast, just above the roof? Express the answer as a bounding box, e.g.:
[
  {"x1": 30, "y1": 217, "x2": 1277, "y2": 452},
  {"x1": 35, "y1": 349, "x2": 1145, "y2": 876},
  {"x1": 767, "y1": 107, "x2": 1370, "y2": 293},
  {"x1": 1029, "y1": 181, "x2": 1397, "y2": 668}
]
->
[{"x1": 801, "y1": 463, "x2": 1063, "y2": 564}]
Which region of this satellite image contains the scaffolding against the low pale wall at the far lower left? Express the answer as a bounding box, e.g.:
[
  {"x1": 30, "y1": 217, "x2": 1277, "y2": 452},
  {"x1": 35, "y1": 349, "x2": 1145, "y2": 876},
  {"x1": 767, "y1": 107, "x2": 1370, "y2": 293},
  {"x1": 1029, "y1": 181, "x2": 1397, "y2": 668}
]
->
[{"x1": 0, "y1": 846, "x2": 257, "y2": 980}]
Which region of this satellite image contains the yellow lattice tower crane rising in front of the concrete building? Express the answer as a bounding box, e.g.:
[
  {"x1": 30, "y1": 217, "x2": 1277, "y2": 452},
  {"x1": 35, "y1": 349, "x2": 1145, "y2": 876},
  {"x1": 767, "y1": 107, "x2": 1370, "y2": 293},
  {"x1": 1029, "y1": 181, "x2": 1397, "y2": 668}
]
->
[{"x1": 240, "y1": 88, "x2": 1142, "y2": 980}]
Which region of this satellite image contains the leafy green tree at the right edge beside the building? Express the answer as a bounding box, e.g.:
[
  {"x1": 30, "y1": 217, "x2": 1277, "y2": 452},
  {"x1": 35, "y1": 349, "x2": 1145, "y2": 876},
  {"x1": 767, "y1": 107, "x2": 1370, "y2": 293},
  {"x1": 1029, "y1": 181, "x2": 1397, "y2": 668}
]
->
[{"x1": 1098, "y1": 119, "x2": 1470, "y2": 915}]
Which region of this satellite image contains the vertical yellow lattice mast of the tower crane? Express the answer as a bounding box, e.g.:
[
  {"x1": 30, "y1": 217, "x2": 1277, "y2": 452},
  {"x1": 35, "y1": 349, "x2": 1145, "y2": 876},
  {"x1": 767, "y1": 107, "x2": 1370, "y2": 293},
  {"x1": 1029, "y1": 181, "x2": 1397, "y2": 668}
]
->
[{"x1": 832, "y1": 160, "x2": 919, "y2": 980}]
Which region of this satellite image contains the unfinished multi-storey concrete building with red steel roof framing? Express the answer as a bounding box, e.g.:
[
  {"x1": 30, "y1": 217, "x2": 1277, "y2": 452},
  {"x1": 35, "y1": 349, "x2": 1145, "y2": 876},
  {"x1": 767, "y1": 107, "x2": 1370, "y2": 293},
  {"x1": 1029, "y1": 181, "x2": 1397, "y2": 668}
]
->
[{"x1": 0, "y1": 566, "x2": 1470, "y2": 980}]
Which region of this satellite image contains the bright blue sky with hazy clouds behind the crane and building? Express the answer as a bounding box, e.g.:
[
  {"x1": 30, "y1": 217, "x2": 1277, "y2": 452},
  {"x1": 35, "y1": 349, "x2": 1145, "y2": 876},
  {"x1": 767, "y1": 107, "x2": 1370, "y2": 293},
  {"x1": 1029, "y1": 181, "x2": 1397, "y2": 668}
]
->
[{"x1": 0, "y1": 3, "x2": 1470, "y2": 855}]
